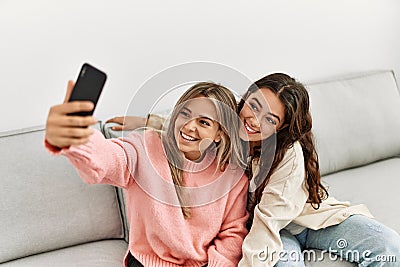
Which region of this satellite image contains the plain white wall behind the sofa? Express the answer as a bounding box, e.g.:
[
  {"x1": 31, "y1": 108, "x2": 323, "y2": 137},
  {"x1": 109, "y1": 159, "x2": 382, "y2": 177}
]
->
[{"x1": 0, "y1": 0, "x2": 400, "y2": 131}]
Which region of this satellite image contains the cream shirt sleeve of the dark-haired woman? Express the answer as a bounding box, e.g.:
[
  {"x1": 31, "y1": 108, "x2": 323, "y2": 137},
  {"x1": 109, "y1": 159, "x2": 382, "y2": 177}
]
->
[{"x1": 239, "y1": 143, "x2": 308, "y2": 267}]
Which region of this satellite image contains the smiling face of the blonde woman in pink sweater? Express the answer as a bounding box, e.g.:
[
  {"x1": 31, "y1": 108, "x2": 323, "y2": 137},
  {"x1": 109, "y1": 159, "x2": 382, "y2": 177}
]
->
[{"x1": 174, "y1": 96, "x2": 222, "y2": 160}]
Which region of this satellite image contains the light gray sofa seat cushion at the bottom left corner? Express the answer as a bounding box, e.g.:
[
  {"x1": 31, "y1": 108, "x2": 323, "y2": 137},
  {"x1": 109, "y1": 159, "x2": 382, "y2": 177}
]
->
[{"x1": 1, "y1": 240, "x2": 128, "y2": 267}]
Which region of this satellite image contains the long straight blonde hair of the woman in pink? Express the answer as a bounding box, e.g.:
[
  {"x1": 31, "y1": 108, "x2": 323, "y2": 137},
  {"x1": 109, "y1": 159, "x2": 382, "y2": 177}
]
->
[{"x1": 162, "y1": 82, "x2": 242, "y2": 218}]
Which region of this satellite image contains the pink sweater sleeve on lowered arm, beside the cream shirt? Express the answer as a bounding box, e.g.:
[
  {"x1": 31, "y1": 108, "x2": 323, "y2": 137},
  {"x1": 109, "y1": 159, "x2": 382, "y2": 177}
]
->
[{"x1": 207, "y1": 175, "x2": 248, "y2": 267}]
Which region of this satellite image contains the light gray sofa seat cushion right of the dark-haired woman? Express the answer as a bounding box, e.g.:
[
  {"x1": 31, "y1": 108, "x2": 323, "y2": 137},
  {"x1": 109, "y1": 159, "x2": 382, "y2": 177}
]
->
[{"x1": 323, "y1": 158, "x2": 400, "y2": 236}]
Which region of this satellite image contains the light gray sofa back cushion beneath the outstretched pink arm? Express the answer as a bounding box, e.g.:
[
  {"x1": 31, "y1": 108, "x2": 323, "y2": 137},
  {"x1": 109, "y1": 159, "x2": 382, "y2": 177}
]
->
[{"x1": 0, "y1": 125, "x2": 124, "y2": 263}]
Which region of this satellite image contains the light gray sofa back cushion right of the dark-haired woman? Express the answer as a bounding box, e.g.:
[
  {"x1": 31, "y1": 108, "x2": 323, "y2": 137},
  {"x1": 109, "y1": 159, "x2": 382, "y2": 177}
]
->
[{"x1": 307, "y1": 71, "x2": 400, "y2": 175}]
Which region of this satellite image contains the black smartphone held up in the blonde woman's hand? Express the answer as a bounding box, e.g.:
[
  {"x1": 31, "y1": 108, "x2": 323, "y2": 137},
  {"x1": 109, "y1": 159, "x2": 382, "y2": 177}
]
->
[{"x1": 68, "y1": 63, "x2": 107, "y2": 116}]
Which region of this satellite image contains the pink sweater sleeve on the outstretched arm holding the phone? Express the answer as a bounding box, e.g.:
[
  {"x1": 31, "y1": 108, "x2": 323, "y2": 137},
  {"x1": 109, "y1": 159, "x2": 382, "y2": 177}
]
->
[{"x1": 45, "y1": 130, "x2": 137, "y2": 188}]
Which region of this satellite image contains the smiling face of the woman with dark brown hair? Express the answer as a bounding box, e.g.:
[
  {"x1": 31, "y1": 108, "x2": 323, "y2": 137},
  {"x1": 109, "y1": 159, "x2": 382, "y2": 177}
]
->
[{"x1": 239, "y1": 88, "x2": 285, "y2": 142}]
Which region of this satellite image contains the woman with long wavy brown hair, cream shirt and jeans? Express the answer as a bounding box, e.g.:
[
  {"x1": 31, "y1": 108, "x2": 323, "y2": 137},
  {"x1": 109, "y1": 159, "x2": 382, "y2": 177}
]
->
[{"x1": 239, "y1": 73, "x2": 400, "y2": 266}]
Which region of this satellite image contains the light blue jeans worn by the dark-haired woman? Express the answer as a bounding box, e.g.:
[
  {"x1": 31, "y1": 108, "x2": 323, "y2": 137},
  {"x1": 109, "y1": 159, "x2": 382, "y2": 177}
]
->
[{"x1": 275, "y1": 215, "x2": 400, "y2": 267}]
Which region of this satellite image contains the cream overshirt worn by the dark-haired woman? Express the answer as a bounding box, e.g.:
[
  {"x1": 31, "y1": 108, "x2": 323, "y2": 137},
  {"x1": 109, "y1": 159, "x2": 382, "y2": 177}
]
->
[{"x1": 239, "y1": 142, "x2": 372, "y2": 267}]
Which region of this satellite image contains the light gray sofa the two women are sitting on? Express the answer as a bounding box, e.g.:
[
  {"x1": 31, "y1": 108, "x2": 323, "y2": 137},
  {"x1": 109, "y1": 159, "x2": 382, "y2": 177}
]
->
[{"x1": 0, "y1": 71, "x2": 400, "y2": 267}]
